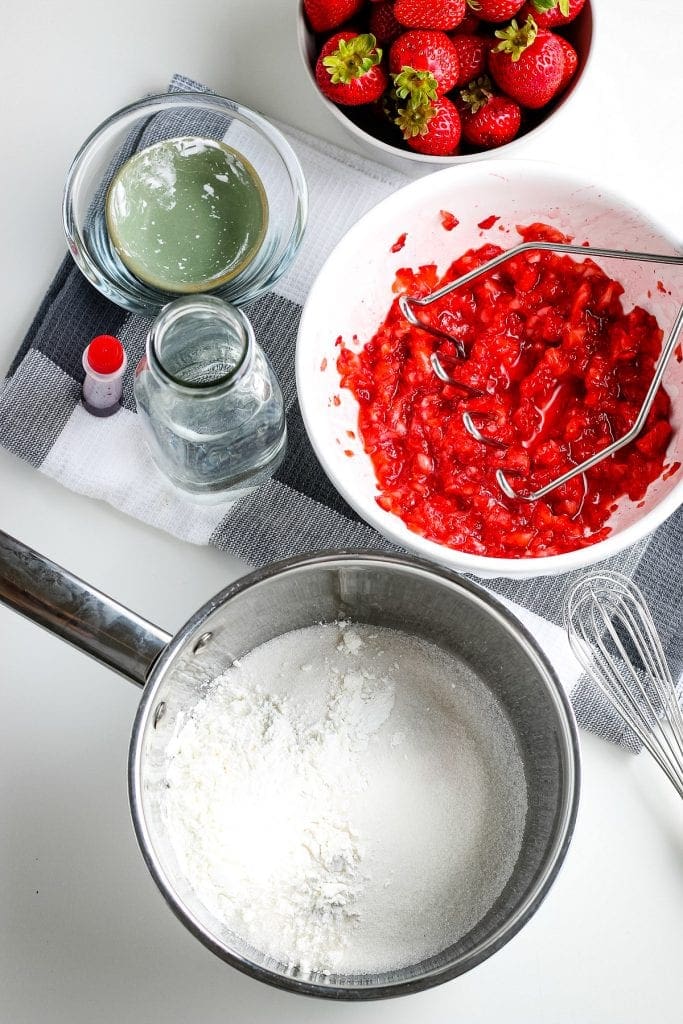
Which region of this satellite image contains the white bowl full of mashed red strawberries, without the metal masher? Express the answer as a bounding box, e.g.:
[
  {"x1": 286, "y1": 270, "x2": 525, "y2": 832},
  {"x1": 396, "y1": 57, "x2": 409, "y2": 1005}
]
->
[{"x1": 296, "y1": 160, "x2": 683, "y2": 578}]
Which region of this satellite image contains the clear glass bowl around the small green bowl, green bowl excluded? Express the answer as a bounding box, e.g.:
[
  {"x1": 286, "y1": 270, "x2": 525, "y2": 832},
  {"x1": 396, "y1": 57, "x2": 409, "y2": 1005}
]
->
[{"x1": 62, "y1": 92, "x2": 307, "y2": 316}]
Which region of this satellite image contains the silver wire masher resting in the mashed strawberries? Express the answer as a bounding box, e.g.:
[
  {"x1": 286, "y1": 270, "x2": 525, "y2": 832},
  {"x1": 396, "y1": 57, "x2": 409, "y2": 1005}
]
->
[{"x1": 398, "y1": 242, "x2": 683, "y2": 502}]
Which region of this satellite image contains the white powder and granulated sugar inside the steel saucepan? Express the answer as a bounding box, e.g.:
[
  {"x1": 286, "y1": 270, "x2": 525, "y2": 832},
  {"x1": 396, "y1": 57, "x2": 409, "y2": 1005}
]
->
[{"x1": 164, "y1": 623, "x2": 526, "y2": 974}]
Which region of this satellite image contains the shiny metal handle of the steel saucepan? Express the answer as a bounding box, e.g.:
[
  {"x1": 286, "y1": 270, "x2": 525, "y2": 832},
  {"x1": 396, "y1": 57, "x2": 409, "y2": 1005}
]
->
[{"x1": 0, "y1": 530, "x2": 171, "y2": 686}]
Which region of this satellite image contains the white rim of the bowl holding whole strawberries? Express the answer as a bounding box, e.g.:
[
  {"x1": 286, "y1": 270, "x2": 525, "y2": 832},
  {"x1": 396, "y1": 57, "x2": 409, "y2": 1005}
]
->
[{"x1": 297, "y1": 0, "x2": 598, "y2": 170}]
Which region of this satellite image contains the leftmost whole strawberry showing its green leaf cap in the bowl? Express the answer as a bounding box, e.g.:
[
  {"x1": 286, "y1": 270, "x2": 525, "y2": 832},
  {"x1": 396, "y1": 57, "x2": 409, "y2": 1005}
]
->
[{"x1": 315, "y1": 32, "x2": 389, "y2": 106}]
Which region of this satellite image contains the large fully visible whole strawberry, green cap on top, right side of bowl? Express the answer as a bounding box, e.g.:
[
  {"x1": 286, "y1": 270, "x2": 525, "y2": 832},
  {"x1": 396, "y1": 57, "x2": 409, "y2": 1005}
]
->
[{"x1": 488, "y1": 16, "x2": 564, "y2": 110}]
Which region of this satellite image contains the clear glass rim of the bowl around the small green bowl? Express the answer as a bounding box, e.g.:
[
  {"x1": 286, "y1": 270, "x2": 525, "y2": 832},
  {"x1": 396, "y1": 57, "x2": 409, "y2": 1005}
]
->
[{"x1": 61, "y1": 89, "x2": 308, "y2": 315}]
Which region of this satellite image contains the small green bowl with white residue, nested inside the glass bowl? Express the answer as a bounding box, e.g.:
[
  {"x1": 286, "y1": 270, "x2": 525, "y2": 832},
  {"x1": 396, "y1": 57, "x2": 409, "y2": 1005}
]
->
[{"x1": 105, "y1": 135, "x2": 268, "y2": 294}]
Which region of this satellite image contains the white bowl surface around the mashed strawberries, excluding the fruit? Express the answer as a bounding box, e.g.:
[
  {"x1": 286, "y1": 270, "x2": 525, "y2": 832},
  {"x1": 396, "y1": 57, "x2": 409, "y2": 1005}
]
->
[{"x1": 296, "y1": 160, "x2": 683, "y2": 577}]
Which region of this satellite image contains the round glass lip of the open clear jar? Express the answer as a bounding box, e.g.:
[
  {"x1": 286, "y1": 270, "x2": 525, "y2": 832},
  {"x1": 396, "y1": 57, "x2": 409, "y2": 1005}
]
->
[{"x1": 145, "y1": 294, "x2": 256, "y2": 395}]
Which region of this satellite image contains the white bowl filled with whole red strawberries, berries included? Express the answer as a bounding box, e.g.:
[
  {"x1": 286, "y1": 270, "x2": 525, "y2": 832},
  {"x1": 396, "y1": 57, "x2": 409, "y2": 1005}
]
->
[{"x1": 299, "y1": 0, "x2": 593, "y2": 165}]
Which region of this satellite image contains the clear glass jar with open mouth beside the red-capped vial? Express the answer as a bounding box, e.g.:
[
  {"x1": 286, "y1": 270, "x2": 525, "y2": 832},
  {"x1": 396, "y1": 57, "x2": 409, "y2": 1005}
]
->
[{"x1": 135, "y1": 295, "x2": 287, "y2": 501}]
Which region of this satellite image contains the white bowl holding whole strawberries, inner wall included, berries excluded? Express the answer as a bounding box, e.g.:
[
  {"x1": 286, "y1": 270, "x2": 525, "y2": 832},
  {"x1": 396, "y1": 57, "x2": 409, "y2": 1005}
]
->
[{"x1": 297, "y1": 0, "x2": 595, "y2": 171}]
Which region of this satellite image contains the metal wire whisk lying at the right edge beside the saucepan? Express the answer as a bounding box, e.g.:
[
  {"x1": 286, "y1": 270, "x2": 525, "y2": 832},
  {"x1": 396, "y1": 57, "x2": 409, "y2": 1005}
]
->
[{"x1": 564, "y1": 571, "x2": 683, "y2": 797}]
